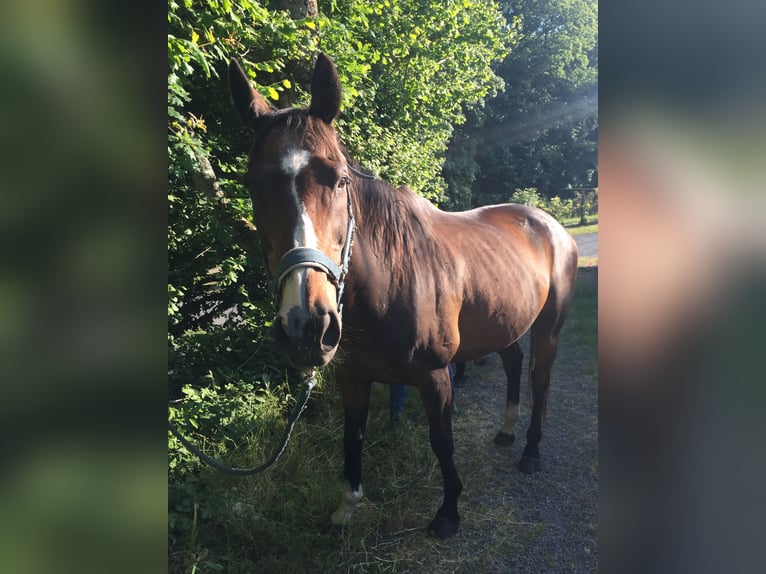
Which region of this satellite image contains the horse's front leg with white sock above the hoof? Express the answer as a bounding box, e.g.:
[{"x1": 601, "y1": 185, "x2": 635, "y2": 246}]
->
[{"x1": 332, "y1": 372, "x2": 371, "y2": 525}]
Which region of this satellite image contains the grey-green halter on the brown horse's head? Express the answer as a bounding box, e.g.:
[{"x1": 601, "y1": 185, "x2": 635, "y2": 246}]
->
[{"x1": 272, "y1": 177, "x2": 356, "y2": 315}]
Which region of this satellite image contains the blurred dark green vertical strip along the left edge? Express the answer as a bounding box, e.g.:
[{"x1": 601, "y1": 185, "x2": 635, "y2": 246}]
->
[{"x1": 0, "y1": 0, "x2": 167, "y2": 573}]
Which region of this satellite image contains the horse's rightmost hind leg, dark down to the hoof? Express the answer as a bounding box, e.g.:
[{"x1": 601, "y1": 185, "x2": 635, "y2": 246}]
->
[{"x1": 518, "y1": 322, "x2": 559, "y2": 474}]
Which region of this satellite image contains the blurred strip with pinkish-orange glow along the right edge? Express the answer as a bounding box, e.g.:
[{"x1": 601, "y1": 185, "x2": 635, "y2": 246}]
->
[{"x1": 599, "y1": 0, "x2": 766, "y2": 573}]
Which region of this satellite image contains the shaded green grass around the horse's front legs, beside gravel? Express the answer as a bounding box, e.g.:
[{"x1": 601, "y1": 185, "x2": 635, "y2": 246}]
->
[{"x1": 170, "y1": 381, "x2": 441, "y2": 573}]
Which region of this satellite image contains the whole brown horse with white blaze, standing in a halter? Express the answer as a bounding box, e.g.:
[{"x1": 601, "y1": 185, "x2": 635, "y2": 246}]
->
[{"x1": 229, "y1": 54, "x2": 577, "y2": 538}]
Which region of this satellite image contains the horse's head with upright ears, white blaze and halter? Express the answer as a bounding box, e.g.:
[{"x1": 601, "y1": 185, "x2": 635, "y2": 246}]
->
[{"x1": 229, "y1": 54, "x2": 354, "y2": 368}]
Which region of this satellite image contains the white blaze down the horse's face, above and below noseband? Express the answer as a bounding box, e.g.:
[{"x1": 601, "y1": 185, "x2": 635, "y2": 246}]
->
[{"x1": 280, "y1": 149, "x2": 317, "y2": 322}]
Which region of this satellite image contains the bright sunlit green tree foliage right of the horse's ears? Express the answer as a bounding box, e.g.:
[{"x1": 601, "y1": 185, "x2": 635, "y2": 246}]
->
[{"x1": 320, "y1": 0, "x2": 516, "y2": 201}]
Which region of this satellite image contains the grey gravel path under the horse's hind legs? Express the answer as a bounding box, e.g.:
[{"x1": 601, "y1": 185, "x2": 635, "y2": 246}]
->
[{"x1": 454, "y1": 320, "x2": 598, "y2": 574}]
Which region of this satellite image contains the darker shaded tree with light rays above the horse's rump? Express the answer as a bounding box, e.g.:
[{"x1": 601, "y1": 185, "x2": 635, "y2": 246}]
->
[{"x1": 445, "y1": 0, "x2": 598, "y2": 208}]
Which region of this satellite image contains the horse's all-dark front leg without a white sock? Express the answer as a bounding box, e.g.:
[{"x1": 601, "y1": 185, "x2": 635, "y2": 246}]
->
[{"x1": 420, "y1": 368, "x2": 463, "y2": 539}]
